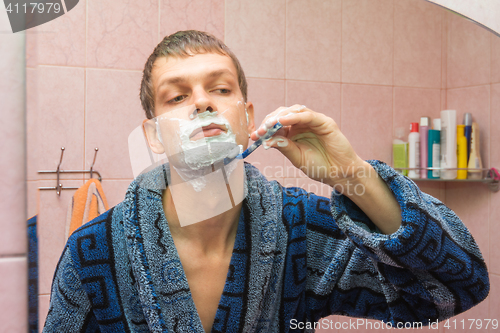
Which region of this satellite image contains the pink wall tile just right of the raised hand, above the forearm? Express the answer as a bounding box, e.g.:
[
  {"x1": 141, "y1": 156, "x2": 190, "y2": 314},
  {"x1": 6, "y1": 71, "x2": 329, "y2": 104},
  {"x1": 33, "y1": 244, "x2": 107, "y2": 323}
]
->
[{"x1": 341, "y1": 84, "x2": 393, "y2": 164}]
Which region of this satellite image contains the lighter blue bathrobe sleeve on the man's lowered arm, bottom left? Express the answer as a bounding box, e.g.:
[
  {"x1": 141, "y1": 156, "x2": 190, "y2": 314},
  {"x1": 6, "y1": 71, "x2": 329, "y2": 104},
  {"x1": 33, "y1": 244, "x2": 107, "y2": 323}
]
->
[{"x1": 43, "y1": 245, "x2": 100, "y2": 333}]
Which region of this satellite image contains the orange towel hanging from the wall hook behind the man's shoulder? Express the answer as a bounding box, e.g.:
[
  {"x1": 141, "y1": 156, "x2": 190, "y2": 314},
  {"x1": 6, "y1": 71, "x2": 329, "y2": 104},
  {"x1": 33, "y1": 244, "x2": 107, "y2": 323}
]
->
[{"x1": 66, "y1": 178, "x2": 109, "y2": 237}]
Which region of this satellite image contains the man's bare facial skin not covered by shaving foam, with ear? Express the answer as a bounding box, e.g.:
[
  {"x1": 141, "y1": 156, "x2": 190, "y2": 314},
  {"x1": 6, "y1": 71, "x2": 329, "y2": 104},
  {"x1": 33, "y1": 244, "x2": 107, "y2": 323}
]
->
[{"x1": 152, "y1": 53, "x2": 255, "y2": 149}]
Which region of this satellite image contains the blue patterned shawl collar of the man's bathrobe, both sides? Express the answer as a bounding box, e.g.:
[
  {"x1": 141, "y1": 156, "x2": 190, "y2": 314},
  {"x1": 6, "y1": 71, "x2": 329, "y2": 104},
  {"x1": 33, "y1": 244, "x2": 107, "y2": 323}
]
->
[{"x1": 124, "y1": 164, "x2": 287, "y2": 333}]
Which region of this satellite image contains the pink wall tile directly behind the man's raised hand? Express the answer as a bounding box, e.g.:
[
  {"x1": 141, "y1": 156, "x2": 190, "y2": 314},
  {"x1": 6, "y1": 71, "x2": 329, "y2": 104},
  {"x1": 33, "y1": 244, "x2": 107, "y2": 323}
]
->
[{"x1": 284, "y1": 80, "x2": 341, "y2": 178}]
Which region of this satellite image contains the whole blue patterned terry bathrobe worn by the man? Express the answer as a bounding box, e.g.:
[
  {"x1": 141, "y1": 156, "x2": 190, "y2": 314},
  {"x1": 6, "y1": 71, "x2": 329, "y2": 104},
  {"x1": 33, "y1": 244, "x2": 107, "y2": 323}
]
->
[{"x1": 44, "y1": 161, "x2": 489, "y2": 333}]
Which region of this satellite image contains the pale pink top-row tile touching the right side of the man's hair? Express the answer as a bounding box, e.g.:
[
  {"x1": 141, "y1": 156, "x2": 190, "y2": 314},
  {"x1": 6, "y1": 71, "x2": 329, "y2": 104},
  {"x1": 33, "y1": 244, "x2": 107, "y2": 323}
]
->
[{"x1": 225, "y1": 0, "x2": 285, "y2": 79}]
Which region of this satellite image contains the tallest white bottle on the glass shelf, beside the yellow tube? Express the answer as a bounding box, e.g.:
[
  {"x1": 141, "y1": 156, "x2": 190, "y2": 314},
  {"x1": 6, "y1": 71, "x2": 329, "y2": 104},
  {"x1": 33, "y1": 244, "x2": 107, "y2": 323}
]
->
[{"x1": 441, "y1": 110, "x2": 457, "y2": 179}]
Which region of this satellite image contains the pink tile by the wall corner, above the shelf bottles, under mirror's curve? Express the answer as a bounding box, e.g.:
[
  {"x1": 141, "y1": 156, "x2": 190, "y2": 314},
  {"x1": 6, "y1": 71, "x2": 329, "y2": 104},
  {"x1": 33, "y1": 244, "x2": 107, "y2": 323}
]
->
[{"x1": 448, "y1": 12, "x2": 491, "y2": 88}]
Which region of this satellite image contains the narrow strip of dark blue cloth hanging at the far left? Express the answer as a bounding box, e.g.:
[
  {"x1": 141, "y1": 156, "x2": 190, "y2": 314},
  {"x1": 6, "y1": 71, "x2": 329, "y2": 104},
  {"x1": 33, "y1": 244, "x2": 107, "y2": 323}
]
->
[{"x1": 28, "y1": 215, "x2": 38, "y2": 333}]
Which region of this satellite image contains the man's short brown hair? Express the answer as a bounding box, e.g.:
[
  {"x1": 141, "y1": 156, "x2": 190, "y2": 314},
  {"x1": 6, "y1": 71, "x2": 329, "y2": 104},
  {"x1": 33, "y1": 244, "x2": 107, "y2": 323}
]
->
[{"x1": 140, "y1": 30, "x2": 247, "y2": 119}]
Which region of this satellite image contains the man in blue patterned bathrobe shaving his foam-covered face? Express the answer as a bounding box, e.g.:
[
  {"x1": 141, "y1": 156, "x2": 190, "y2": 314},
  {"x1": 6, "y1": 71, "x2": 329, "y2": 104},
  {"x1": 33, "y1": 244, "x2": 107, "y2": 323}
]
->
[{"x1": 44, "y1": 31, "x2": 489, "y2": 332}]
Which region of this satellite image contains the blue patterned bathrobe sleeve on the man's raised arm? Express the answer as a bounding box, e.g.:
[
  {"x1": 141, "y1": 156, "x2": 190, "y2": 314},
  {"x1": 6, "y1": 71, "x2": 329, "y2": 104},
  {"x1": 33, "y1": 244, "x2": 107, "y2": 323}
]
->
[{"x1": 294, "y1": 161, "x2": 489, "y2": 326}]
